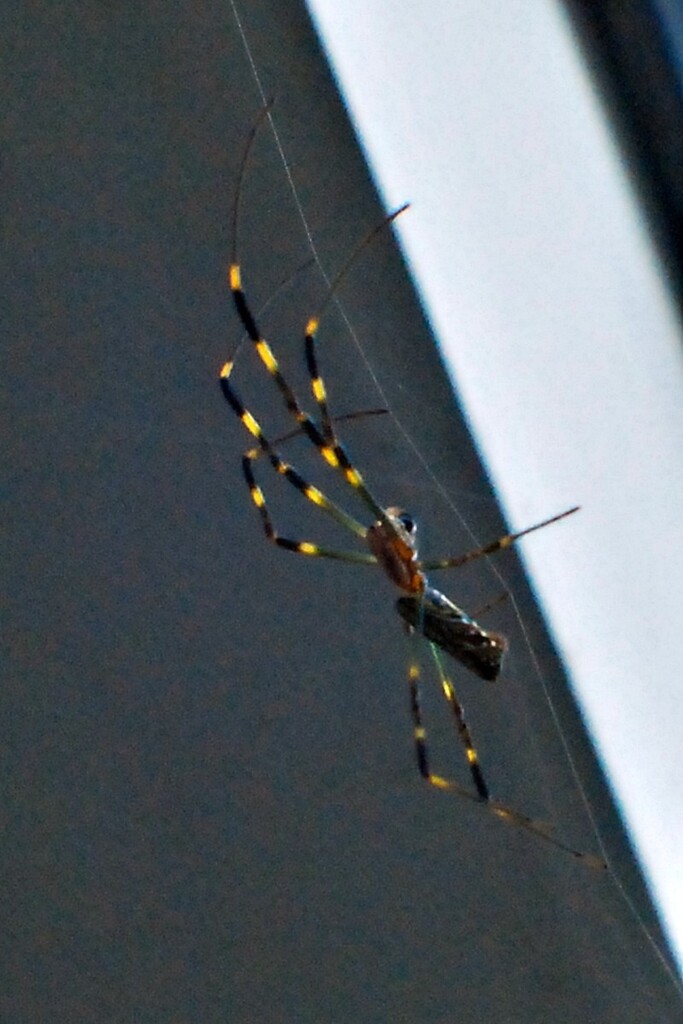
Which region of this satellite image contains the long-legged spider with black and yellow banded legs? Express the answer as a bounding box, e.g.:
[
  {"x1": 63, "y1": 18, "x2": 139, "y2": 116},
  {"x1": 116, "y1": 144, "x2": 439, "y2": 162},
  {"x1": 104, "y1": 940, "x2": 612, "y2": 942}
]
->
[{"x1": 219, "y1": 104, "x2": 604, "y2": 866}]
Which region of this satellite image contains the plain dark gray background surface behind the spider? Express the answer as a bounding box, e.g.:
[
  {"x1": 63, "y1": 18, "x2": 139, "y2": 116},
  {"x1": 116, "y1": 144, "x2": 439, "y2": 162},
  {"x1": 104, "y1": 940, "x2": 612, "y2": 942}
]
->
[{"x1": 5, "y1": 0, "x2": 681, "y2": 1024}]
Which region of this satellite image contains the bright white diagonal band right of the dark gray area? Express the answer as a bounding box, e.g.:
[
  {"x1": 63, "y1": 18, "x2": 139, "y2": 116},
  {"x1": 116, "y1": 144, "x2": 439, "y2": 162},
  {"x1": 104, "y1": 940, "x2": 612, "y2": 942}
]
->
[{"x1": 310, "y1": 0, "x2": 683, "y2": 974}]
